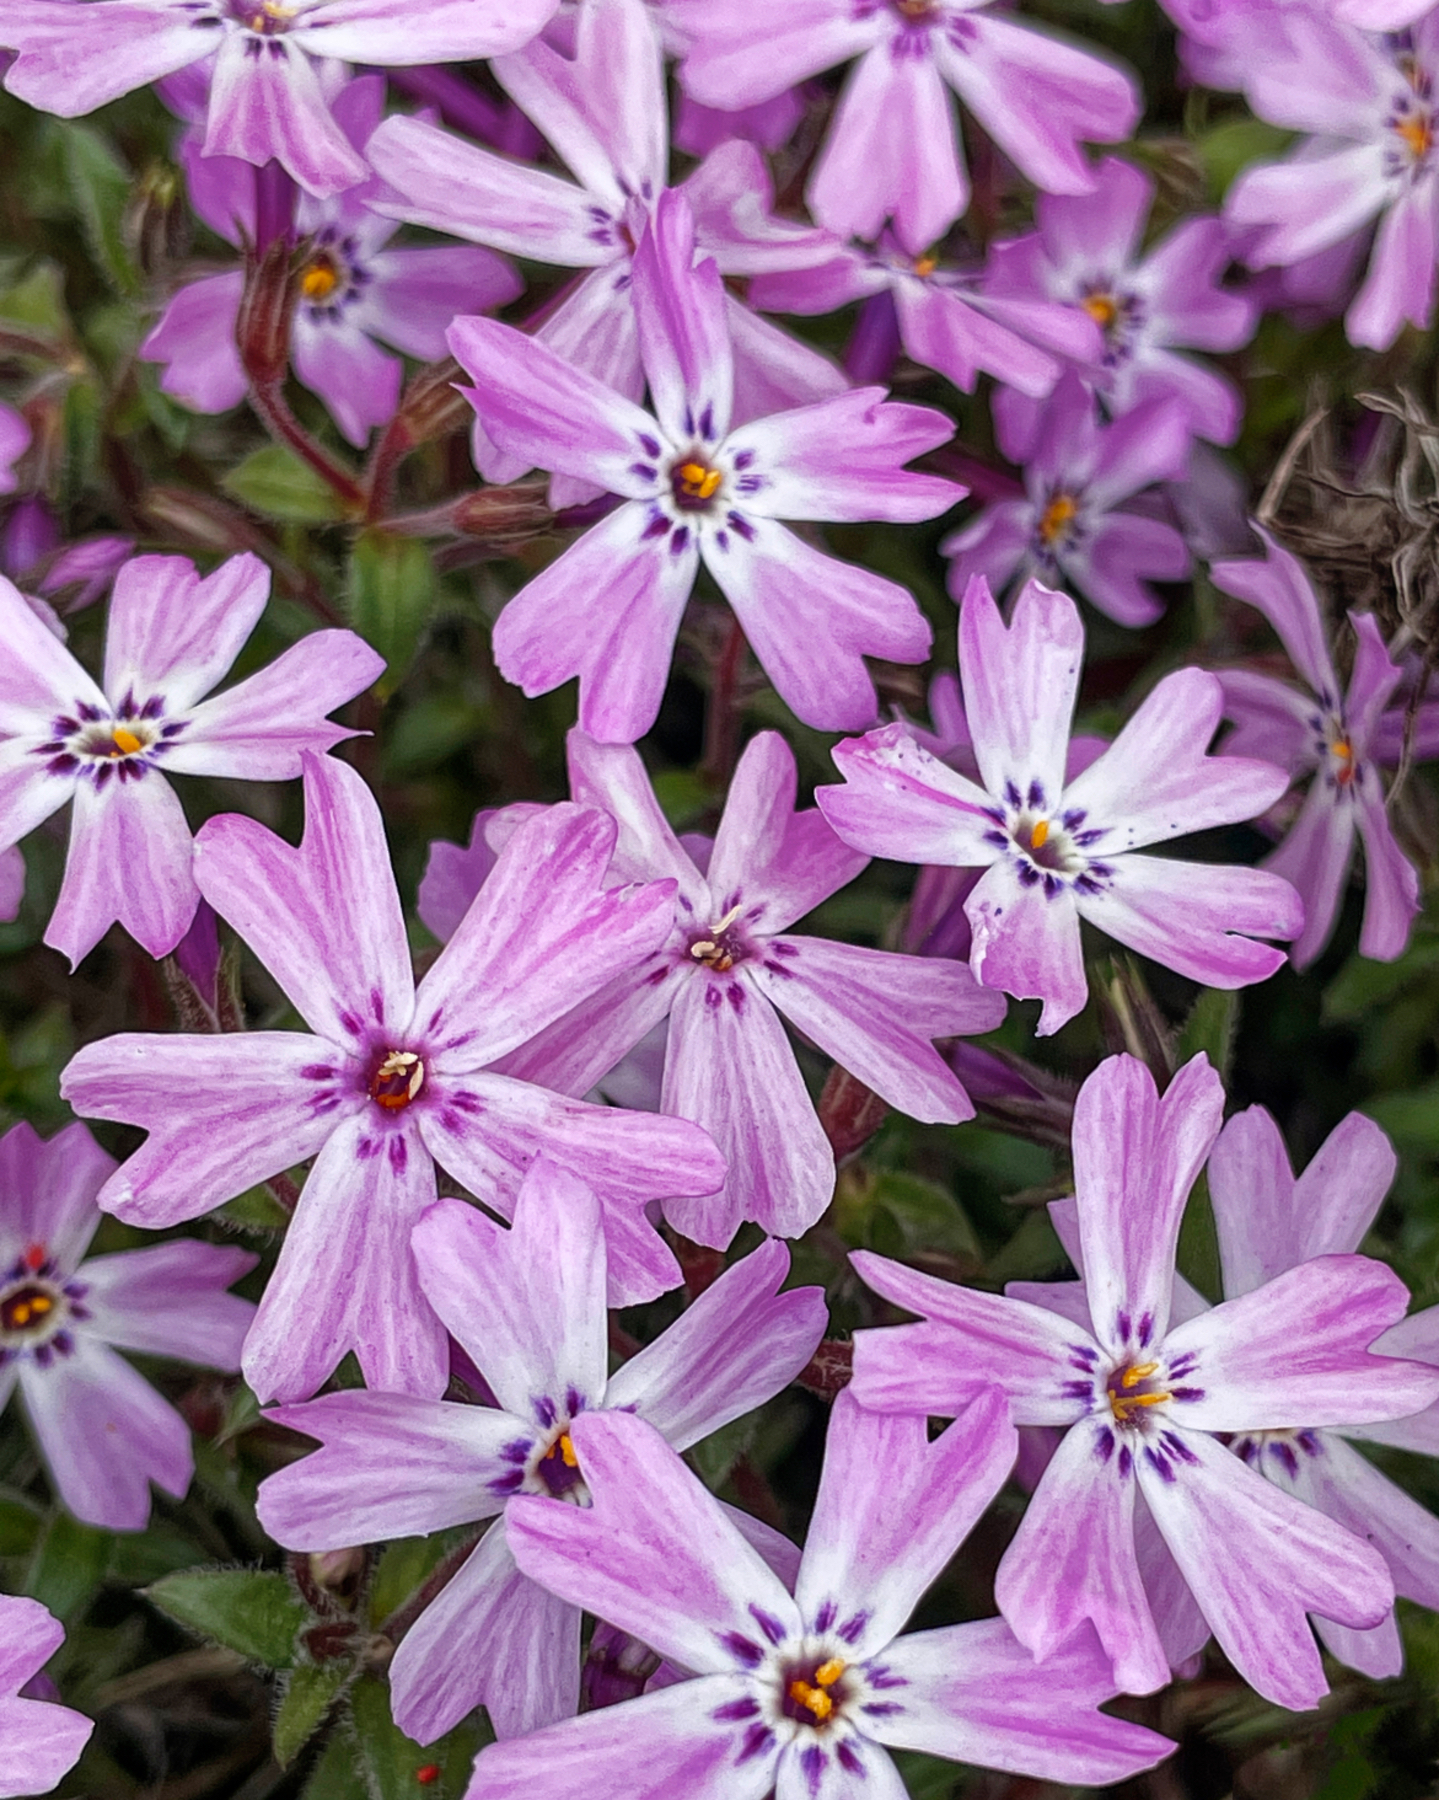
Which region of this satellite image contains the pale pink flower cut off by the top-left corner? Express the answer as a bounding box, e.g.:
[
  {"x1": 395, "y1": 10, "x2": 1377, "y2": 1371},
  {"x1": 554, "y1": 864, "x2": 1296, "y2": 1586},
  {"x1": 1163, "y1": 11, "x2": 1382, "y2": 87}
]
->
[{"x1": 0, "y1": 0, "x2": 557, "y2": 194}]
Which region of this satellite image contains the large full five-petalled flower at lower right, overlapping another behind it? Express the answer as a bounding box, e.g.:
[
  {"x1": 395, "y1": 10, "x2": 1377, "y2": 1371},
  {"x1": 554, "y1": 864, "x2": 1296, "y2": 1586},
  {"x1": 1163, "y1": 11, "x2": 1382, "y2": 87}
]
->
[{"x1": 852, "y1": 1057, "x2": 1439, "y2": 1708}]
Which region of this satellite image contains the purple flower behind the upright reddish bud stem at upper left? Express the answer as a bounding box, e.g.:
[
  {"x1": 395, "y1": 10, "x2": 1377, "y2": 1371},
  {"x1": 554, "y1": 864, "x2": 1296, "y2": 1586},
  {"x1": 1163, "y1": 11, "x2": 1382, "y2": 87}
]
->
[{"x1": 140, "y1": 76, "x2": 522, "y2": 445}]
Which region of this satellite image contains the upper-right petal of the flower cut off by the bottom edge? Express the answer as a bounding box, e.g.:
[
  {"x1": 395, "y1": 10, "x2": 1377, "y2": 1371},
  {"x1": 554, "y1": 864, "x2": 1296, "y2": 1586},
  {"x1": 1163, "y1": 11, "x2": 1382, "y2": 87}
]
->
[{"x1": 794, "y1": 1388, "x2": 1019, "y2": 1661}]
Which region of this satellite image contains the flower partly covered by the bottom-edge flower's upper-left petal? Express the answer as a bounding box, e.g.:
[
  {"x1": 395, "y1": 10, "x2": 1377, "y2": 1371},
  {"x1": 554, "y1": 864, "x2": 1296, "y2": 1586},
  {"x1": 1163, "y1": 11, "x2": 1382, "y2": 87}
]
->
[{"x1": 259, "y1": 1157, "x2": 827, "y2": 1744}]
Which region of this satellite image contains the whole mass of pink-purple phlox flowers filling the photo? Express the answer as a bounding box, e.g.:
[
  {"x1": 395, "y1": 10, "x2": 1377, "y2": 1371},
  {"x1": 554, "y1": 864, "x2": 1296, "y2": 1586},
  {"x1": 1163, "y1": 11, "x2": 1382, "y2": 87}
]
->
[{"x1": 0, "y1": 0, "x2": 1439, "y2": 1800}]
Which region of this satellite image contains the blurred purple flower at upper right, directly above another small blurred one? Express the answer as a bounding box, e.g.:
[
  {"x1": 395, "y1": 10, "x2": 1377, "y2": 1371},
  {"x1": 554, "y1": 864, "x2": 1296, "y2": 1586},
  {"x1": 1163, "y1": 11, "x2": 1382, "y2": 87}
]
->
[{"x1": 985, "y1": 157, "x2": 1255, "y2": 445}]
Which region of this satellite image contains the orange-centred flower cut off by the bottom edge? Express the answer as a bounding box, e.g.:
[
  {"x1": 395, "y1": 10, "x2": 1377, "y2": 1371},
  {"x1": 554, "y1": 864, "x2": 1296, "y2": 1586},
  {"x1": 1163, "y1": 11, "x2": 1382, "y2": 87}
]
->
[{"x1": 466, "y1": 1390, "x2": 1172, "y2": 1800}]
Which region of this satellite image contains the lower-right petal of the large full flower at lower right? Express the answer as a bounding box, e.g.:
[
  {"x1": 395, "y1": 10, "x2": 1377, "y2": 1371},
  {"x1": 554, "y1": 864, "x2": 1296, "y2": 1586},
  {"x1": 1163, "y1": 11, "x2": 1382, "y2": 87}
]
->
[{"x1": 1138, "y1": 1431, "x2": 1394, "y2": 1712}]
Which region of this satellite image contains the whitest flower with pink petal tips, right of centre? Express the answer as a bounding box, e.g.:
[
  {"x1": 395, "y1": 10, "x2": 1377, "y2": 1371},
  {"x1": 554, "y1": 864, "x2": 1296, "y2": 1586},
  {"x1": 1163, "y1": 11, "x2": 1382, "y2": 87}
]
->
[{"x1": 816, "y1": 579, "x2": 1304, "y2": 1037}]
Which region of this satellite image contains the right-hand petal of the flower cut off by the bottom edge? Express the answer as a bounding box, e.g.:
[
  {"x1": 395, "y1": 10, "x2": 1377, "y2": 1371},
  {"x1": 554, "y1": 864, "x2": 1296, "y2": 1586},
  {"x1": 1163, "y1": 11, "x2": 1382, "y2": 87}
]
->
[{"x1": 864, "y1": 1618, "x2": 1174, "y2": 1787}]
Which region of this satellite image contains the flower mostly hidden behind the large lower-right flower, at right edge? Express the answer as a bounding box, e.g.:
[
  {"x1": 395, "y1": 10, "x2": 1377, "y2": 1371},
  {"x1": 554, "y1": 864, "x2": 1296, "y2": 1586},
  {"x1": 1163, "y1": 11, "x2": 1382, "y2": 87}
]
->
[{"x1": 1208, "y1": 1107, "x2": 1439, "y2": 1679}]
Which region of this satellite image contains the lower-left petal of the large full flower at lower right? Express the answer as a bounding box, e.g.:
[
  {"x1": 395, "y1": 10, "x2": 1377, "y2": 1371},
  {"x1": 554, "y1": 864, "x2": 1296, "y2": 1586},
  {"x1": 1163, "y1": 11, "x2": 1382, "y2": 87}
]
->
[{"x1": 994, "y1": 1418, "x2": 1169, "y2": 1694}]
